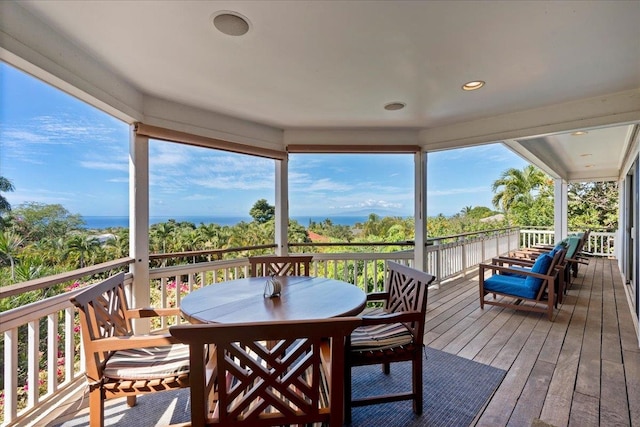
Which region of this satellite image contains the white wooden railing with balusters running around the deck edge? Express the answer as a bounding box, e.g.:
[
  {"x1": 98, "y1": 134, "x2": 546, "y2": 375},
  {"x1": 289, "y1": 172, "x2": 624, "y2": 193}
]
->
[{"x1": 0, "y1": 228, "x2": 613, "y2": 426}]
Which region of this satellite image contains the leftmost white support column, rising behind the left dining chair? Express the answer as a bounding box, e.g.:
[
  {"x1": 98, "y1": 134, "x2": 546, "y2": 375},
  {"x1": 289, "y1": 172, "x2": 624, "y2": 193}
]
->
[{"x1": 129, "y1": 126, "x2": 151, "y2": 333}]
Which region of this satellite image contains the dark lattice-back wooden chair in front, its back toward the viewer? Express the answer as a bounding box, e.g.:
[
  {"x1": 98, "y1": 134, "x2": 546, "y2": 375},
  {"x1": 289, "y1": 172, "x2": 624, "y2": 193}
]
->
[{"x1": 169, "y1": 317, "x2": 361, "y2": 427}]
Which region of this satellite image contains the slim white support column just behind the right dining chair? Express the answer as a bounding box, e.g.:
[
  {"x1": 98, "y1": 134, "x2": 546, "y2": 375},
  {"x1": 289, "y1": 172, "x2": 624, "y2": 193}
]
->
[{"x1": 413, "y1": 151, "x2": 427, "y2": 271}]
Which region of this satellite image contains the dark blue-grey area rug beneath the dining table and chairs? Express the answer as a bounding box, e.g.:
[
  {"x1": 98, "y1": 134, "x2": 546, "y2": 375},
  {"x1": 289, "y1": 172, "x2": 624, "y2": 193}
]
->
[{"x1": 53, "y1": 347, "x2": 505, "y2": 427}]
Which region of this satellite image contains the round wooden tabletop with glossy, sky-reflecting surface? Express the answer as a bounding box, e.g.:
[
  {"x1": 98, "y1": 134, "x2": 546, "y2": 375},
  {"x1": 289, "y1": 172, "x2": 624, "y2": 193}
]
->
[{"x1": 180, "y1": 276, "x2": 366, "y2": 323}]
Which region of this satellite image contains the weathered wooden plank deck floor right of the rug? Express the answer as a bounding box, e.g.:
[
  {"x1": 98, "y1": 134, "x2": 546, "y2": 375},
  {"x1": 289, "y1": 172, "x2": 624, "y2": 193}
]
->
[{"x1": 425, "y1": 258, "x2": 640, "y2": 427}]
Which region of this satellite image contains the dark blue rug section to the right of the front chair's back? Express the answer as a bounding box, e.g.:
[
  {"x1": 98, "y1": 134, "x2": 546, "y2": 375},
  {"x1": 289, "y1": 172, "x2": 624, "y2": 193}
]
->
[{"x1": 352, "y1": 347, "x2": 506, "y2": 427}]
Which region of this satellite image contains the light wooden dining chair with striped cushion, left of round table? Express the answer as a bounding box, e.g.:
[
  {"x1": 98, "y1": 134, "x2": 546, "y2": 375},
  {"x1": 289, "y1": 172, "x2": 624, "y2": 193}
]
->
[{"x1": 71, "y1": 273, "x2": 189, "y2": 427}]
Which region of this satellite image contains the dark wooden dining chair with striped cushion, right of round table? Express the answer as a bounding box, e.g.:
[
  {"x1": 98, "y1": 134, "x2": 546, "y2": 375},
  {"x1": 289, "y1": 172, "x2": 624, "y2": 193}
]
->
[{"x1": 345, "y1": 261, "x2": 435, "y2": 423}]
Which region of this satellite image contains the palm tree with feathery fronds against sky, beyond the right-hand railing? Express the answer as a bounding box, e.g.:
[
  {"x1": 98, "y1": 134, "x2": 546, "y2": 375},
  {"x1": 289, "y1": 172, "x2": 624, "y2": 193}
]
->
[{"x1": 491, "y1": 165, "x2": 546, "y2": 213}]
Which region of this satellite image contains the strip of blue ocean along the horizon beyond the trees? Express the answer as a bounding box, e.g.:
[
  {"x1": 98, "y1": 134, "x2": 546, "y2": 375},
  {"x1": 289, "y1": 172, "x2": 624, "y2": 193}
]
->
[{"x1": 82, "y1": 216, "x2": 367, "y2": 230}]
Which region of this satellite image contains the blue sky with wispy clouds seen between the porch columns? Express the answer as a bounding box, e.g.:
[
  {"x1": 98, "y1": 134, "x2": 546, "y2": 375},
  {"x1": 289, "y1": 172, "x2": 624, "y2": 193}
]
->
[{"x1": 0, "y1": 62, "x2": 526, "y2": 221}]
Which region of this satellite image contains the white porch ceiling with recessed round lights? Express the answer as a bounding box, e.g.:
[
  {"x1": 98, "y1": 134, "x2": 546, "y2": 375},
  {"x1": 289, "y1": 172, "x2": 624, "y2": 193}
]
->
[{"x1": 5, "y1": 0, "x2": 640, "y2": 179}]
